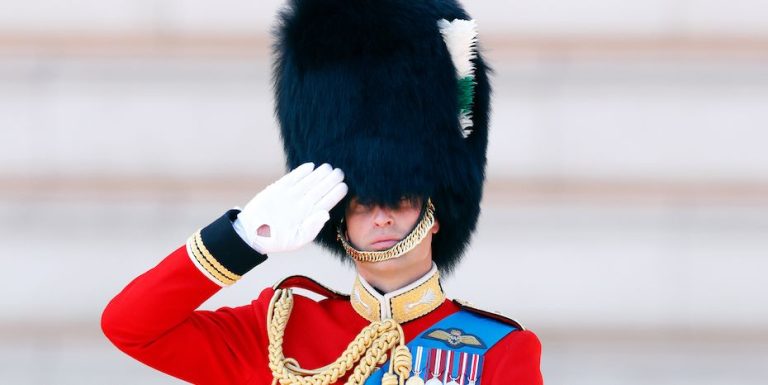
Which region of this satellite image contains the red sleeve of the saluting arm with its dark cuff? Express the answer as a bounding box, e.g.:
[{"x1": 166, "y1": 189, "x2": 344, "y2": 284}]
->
[{"x1": 101, "y1": 210, "x2": 271, "y2": 384}]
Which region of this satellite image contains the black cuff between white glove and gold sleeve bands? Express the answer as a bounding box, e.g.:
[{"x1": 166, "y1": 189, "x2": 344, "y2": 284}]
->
[{"x1": 200, "y1": 209, "x2": 267, "y2": 275}]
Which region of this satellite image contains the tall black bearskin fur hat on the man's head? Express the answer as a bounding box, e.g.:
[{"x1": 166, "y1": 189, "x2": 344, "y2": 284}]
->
[{"x1": 274, "y1": 0, "x2": 490, "y2": 272}]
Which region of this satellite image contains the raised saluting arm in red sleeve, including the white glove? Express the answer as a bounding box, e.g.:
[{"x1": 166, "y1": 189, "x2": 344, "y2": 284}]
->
[{"x1": 102, "y1": 163, "x2": 347, "y2": 384}]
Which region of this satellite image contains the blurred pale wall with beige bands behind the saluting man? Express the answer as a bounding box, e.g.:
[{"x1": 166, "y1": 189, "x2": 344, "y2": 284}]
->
[{"x1": 0, "y1": 0, "x2": 768, "y2": 385}]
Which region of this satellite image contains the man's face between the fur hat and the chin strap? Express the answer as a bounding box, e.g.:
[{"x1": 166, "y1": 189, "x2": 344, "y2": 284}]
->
[{"x1": 346, "y1": 198, "x2": 421, "y2": 251}]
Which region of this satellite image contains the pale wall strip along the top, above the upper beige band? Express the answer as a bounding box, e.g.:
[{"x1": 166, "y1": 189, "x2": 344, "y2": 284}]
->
[{"x1": 0, "y1": 0, "x2": 768, "y2": 36}]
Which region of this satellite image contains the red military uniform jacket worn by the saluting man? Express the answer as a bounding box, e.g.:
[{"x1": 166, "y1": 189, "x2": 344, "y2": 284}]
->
[{"x1": 102, "y1": 211, "x2": 542, "y2": 385}]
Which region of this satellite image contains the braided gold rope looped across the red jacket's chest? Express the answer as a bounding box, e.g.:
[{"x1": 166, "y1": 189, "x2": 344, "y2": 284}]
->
[{"x1": 267, "y1": 289, "x2": 411, "y2": 385}]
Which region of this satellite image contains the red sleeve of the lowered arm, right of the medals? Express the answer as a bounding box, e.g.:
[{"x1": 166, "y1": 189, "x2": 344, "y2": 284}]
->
[{"x1": 480, "y1": 330, "x2": 543, "y2": 385}]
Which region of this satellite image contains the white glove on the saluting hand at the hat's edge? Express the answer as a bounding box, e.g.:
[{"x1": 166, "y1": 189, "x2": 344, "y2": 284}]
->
[{"x1": 233, "y1": 163, "x2": 347, "y2": 254}]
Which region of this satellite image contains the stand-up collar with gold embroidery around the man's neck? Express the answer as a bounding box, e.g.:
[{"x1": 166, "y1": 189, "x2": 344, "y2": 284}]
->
[{"x1": 350, "y1": 264, "x2": 445, "y2": 323}]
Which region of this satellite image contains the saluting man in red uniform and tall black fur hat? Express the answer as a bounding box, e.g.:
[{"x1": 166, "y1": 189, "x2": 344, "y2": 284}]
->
[{"x1": 102, "y1": 0, "x2": 542, "y2": 385}]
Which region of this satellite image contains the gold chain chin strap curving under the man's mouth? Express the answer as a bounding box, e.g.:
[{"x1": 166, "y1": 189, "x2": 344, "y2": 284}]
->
[{"x1": 336, "y1": 199, "x2": 435, "y2": 262}]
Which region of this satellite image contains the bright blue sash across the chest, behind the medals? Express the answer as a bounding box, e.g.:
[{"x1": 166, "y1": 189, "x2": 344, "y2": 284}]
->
[{"x1": 365, "y1": 309, "x2": 516, "y2": 385}]
